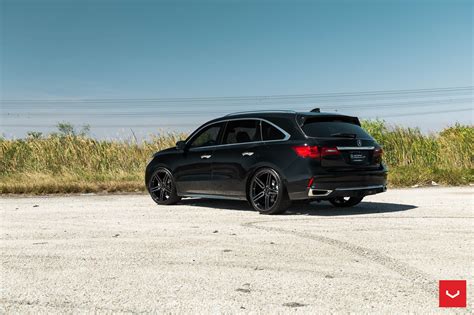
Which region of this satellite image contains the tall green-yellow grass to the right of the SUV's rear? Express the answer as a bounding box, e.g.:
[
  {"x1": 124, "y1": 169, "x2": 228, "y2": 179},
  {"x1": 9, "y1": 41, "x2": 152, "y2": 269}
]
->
[{"x1": 363, "y1": 121, "x2": 474, "y2": 186}]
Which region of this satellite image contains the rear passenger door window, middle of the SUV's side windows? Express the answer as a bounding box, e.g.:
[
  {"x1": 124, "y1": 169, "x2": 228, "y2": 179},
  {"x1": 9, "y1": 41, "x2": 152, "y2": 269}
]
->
[{"x1": 222, "y1": 119, "x2": 261, "y2": 144}]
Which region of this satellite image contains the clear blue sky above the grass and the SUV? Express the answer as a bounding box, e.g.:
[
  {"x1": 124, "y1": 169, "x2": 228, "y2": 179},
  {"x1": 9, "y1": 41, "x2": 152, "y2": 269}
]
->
[{"x1": 0, "y1": 0, "x2": 474, "y2": 137}]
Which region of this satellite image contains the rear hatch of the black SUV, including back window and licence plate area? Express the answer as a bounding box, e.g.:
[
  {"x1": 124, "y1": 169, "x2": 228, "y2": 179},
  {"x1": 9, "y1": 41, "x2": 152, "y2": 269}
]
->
[{"x1": 298, "y1": 115, "x2": 382, "y2": 171}]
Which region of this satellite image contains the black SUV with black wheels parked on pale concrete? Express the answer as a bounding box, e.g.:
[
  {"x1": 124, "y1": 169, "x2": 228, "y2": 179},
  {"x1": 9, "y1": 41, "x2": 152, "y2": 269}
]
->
[{"x1": 145, "y1": 110, "x2": 387, "y2": 214}]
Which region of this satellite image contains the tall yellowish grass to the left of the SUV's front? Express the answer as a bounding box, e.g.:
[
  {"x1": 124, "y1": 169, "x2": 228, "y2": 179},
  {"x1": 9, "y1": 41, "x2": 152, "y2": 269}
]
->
[{"x1": 0, "y1": 133, "x2": 185, "y2": 193}]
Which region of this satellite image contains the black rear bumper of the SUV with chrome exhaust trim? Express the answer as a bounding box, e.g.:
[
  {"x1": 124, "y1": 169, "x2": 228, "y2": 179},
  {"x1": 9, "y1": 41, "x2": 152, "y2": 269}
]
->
[{"x1": 289, "y1": 168, "x2": 387, "y2": 200}]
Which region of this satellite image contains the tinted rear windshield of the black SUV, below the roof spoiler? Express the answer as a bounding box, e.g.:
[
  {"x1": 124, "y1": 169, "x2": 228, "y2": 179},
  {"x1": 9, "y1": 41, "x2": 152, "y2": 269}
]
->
[{"x1": 301, "y1": 119, "x2": 371, "y2": 139}]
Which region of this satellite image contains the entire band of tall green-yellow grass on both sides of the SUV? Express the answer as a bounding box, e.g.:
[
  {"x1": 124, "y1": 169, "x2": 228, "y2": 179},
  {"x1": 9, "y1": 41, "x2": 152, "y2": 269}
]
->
[{"x1": 0, "y1": 121, "x2": 474, "y2": 194}]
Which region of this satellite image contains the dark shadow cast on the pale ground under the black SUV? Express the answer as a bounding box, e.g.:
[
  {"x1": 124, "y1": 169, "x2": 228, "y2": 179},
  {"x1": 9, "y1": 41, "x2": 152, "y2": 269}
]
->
[{"x1": 181, "y1": 198, "x2": 417, "y2": 216}]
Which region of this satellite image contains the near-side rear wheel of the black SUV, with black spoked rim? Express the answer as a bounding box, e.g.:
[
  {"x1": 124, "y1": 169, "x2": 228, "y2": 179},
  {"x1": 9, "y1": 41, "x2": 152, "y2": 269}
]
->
[{"x1": 248, "y1": 168, "x2": 291, "y2": 214}]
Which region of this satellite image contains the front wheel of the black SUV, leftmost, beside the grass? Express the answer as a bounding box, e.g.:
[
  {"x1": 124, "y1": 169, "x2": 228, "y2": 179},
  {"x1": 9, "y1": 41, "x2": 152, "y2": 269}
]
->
[{"x1": 147, "y1": 168, "x2": 181, "y2": 205}]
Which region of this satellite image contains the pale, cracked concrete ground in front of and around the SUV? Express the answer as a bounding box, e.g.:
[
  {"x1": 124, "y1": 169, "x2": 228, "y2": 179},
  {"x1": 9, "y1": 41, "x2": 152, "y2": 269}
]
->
[{"x1": 0, "y1": 187, "x2": 474, "y2": 313}]
